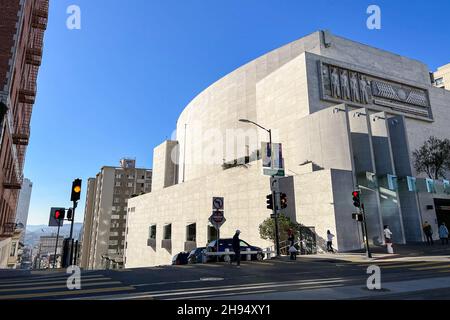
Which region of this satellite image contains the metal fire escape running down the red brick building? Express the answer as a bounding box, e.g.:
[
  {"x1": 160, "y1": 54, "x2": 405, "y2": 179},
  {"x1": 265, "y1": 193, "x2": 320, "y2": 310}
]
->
[{"x1": 4, "y1": 0, "x2": 49, "y2": 190}]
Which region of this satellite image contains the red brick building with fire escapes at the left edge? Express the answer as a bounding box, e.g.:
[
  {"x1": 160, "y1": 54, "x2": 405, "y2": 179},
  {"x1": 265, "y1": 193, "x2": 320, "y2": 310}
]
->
[{"x1": 0, "y1": 0, "x2": 49, "y2": 268}]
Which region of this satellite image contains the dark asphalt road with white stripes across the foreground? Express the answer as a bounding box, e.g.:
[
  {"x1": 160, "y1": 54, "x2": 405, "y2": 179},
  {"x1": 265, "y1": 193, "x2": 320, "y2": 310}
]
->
[{"x1": 0, "y1": 259, "x2": 450, "y2": 300}]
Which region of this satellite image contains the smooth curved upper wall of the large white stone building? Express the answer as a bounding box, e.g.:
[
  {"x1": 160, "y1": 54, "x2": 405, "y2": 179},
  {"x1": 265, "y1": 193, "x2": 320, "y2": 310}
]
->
[{"x1": 177, "y1": 32, "x2": 320, "y2": 182}]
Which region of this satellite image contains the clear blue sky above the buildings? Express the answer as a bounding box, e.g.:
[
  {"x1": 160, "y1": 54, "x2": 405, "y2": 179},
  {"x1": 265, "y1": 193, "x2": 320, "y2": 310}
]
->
[{"x1": 25, "y1": 0, "x2": 450, "y2": 224}]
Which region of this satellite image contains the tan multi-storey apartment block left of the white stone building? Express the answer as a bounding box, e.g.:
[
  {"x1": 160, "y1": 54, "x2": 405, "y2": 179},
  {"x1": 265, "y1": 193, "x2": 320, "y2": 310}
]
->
[{"x1": 80, "y1": 159, "x2": 152, "y2": 269}]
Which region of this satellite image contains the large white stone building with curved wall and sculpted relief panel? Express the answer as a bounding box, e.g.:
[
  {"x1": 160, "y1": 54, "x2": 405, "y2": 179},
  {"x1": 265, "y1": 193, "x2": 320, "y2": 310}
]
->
[{"x1": 125, "y1": 31, "x2": 450, "y2": 268}]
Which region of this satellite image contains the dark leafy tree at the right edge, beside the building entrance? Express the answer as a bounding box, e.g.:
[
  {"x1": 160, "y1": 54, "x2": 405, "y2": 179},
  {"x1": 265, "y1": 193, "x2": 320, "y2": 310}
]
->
[{"x1": 413, "y1": 136, "x2": 450, "y2": 180}]
